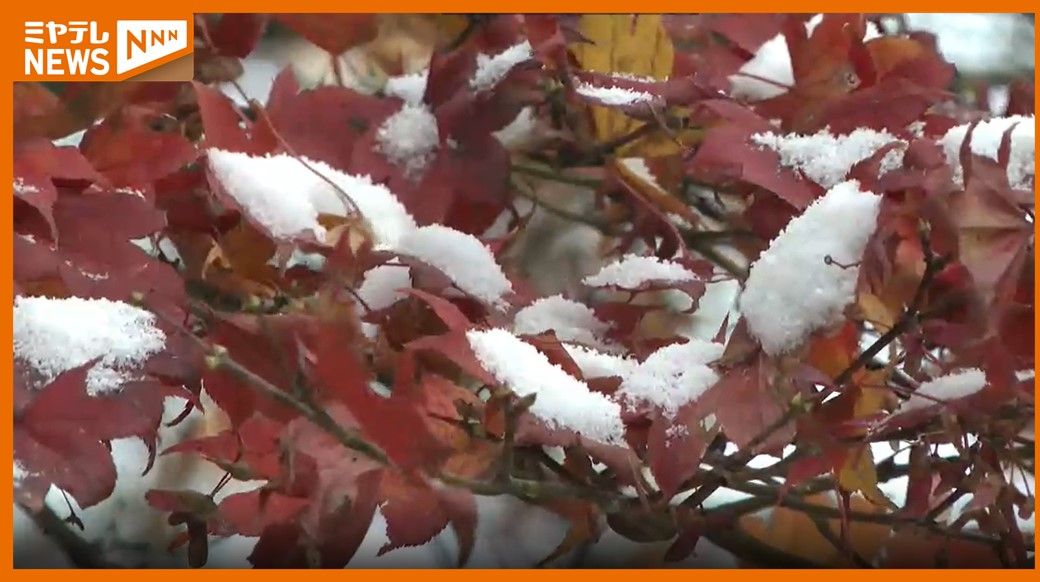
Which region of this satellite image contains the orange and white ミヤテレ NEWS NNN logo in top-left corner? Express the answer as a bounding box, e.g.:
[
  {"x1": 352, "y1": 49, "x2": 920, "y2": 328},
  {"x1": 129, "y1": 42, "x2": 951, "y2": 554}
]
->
[{"x1": 24, "y1": 20, "x2": 191, "y2": 80}]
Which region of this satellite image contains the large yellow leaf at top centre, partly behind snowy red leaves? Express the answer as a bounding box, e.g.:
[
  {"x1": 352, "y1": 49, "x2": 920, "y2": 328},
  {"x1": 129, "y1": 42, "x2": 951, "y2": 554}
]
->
[{"x1": 571, "y1": 15, "x2": 678, "y2": 155}]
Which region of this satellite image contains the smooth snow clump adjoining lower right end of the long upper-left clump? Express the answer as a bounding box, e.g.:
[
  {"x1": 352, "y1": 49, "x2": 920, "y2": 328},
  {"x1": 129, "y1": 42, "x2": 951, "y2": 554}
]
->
[{"x1": 397, "y1": 224, "x2": 513, "y2": 308}]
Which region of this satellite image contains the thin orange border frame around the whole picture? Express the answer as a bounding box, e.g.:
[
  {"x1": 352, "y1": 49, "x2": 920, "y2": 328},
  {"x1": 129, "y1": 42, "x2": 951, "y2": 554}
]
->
[{"x1": 0, "y1": 0, "x2": 1040, "y2": 582}]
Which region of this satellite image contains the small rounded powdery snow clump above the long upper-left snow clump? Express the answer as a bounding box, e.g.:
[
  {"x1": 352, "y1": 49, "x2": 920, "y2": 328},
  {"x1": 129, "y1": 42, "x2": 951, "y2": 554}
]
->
[{"x1": 375, "y1": 103, "x2": 440, "y2": 178}]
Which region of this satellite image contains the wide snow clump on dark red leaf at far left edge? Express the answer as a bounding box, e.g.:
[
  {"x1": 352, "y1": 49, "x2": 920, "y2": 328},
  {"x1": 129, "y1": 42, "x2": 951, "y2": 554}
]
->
[{"x1": 14, "y1": 296, "x2": 166, "y2": 395}]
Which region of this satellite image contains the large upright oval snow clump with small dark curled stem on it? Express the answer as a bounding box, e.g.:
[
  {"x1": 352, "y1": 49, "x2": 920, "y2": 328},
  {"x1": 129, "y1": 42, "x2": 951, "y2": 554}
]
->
[{"x1": 739, "y1": 180, "x2": 881, "y2": 355}]
